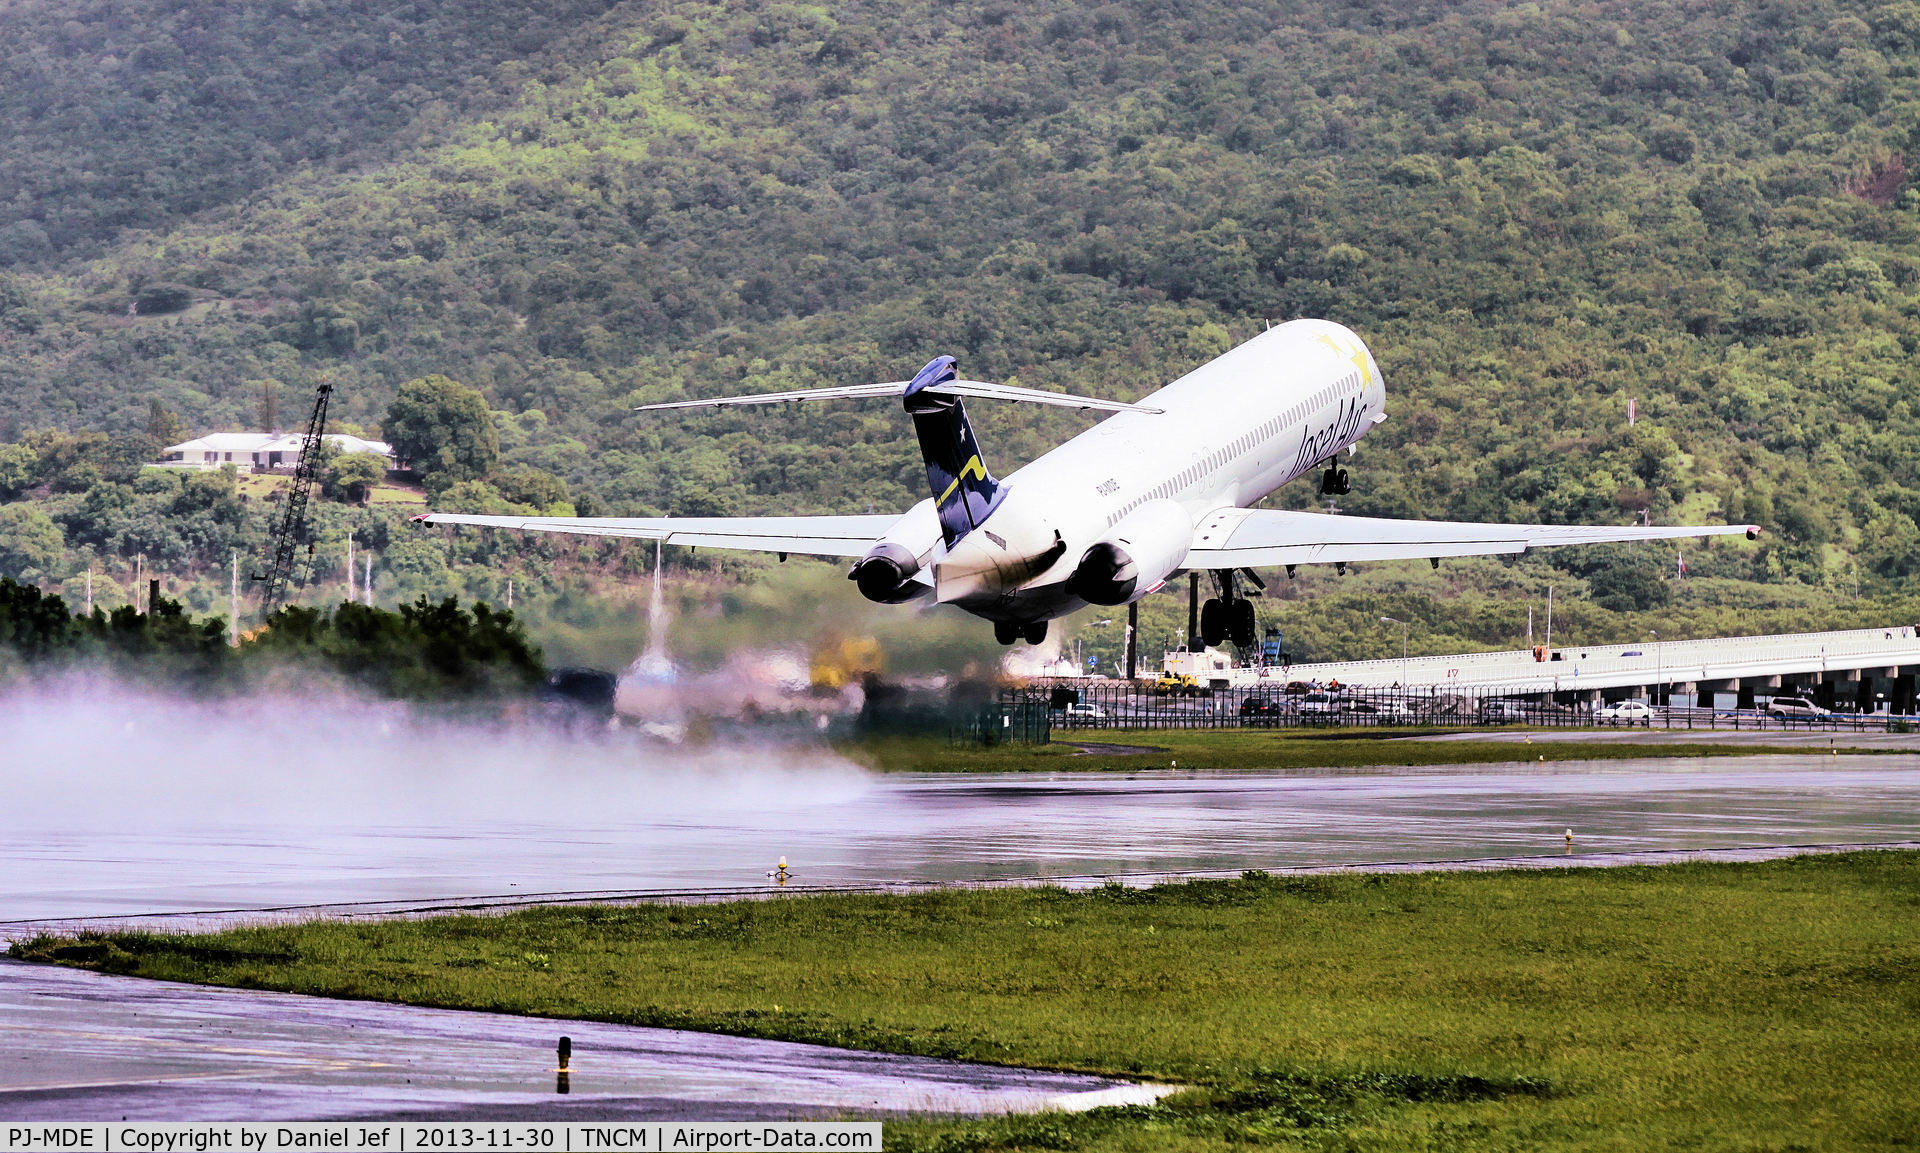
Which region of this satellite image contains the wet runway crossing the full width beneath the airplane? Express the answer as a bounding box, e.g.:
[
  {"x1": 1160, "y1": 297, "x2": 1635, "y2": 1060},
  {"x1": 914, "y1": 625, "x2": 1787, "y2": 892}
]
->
[{"x1": 0, "y1": 750, "x2": 1920, "y2": 924}]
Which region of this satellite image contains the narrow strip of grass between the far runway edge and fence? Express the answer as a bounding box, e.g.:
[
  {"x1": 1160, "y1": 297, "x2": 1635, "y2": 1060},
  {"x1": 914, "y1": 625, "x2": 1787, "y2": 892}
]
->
[{"x1": 835, "y1": 729, "x2": 1873, "y2": 773}]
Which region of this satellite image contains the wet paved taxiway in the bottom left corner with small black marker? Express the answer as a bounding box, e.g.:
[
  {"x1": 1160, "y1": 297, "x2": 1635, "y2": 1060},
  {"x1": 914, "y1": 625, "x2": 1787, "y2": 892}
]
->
[{"x1": 0, "y1": 961, "x2": 1165, "y2": 1120}]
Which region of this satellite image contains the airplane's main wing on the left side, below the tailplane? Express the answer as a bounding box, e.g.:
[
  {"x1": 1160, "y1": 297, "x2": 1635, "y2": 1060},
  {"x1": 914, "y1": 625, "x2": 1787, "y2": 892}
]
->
[{"x1": 413, "y1": 512, "x2": 900, "y2": 556}]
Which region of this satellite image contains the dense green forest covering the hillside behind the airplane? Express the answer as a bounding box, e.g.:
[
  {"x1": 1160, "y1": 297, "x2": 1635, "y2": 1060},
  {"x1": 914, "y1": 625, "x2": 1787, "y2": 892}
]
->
[{"x1": 0, "y1": 0, "x2": 1920, "y2": 663}]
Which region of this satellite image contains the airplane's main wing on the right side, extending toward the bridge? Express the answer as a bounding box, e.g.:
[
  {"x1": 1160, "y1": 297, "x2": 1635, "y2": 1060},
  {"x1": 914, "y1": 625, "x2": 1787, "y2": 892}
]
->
[{"x1": 1185, "y1": 508, "x2": 1761, "y2": 568}]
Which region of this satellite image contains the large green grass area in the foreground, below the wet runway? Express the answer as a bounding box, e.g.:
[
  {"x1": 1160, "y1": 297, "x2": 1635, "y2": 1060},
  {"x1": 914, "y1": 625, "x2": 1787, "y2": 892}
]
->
[{"x1": 15, "y1": 852, "x2": 1920, "y2": 1151}]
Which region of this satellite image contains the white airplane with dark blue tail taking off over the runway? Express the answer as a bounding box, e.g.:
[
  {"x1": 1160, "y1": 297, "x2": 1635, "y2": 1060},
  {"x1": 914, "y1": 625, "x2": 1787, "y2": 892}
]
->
[{"x1": 417, "y1": 320, "x2": 1759, "y2": 647}]
